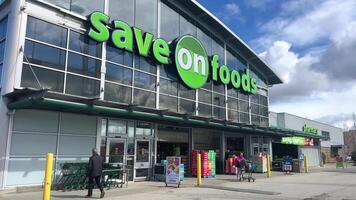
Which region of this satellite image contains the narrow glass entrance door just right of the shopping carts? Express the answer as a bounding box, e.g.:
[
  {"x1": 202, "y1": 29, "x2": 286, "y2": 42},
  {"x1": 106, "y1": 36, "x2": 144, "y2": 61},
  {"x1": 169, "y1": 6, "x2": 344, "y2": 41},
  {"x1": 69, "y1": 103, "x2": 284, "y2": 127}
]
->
[{"x1": 135, "y1": 139, "x2": 151, "y2": 181}]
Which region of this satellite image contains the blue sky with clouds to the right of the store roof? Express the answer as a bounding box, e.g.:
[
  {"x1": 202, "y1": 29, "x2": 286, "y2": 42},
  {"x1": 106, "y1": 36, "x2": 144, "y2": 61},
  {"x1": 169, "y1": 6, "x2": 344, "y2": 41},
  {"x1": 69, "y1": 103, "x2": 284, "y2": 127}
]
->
[{"x1": 198, "y1": 0, "x2": 356, "y2": 129}]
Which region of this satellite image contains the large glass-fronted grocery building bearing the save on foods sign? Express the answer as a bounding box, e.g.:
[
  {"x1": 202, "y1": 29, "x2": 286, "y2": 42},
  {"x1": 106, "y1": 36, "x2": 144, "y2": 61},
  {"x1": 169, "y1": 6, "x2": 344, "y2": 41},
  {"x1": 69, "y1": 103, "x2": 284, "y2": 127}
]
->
[{"x1": 0, "y1": 0, "x2": 321, "y2": 188}]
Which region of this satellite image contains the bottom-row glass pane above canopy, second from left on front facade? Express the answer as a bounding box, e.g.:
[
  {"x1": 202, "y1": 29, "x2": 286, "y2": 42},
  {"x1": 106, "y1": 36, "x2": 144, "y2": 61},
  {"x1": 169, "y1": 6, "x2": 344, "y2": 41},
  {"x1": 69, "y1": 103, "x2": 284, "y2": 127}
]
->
[{"x1": 66, "y1": 74, "x2": 100, "y2": 97}]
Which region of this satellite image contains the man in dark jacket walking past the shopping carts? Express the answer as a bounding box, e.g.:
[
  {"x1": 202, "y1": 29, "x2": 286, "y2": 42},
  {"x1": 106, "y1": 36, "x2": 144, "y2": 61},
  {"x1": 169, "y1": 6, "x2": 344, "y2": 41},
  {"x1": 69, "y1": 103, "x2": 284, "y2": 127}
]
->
[{"x1": 85, "y1": 148, "x2": 105, "y2": 198}]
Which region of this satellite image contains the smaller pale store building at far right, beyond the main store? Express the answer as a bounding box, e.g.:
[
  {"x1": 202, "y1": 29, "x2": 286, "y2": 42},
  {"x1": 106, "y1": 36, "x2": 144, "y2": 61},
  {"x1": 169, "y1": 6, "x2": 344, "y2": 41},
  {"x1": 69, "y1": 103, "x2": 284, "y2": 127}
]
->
[{"x1": 269, "y1": 112, "x2": 344, "y2": 166}]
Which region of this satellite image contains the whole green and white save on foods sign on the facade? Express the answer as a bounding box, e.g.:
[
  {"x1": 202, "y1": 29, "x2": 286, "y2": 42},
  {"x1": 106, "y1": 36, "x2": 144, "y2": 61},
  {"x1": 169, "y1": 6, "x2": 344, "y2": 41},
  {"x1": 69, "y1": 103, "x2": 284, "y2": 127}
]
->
[{"x1": 87, "y1": 12, "x2": 257, "y2": 94}]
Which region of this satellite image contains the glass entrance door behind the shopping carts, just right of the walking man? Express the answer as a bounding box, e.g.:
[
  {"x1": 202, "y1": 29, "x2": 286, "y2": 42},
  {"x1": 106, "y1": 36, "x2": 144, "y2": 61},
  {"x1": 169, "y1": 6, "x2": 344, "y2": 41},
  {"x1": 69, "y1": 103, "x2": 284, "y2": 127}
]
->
[{"x1": 105, "y1": 138, "x2": 126, "y2": 165}]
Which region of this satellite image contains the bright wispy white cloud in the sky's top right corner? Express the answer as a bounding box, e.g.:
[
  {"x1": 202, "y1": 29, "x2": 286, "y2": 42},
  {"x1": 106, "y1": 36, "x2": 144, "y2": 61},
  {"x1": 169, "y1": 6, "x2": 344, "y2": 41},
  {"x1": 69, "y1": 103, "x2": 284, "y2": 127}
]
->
[{"x1": 255, "y1": 0, "x2": 356, "y2": 46}]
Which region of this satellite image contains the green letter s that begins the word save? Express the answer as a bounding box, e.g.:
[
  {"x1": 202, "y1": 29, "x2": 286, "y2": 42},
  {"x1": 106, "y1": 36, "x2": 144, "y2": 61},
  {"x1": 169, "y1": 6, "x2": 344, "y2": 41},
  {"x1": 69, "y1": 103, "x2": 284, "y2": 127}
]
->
[{"x1": 88, "y1": 12, "x2": 110, "y2": 42}]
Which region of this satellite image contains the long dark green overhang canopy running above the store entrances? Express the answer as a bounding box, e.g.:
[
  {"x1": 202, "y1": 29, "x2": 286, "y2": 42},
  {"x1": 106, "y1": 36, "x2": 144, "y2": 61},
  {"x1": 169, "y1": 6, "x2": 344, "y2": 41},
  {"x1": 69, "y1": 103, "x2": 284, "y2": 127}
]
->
[{"x1": 6, "y1": 89, "x2": 324, "y2": 139}]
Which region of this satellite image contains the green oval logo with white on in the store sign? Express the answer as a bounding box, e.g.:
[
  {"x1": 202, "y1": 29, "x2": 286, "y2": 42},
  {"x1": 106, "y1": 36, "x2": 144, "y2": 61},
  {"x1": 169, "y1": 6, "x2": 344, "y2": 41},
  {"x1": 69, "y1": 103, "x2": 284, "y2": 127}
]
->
[{"x1": 175, "y1": 35, "x2": 209, "y2": 89}]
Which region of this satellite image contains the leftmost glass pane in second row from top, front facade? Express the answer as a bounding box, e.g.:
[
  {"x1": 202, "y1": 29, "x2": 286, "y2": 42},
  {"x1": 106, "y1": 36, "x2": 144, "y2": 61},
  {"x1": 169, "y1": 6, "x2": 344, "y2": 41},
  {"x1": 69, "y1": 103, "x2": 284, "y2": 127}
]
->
[{"x1": 24, "y1": 40, "x2": 66, "y2": 70}]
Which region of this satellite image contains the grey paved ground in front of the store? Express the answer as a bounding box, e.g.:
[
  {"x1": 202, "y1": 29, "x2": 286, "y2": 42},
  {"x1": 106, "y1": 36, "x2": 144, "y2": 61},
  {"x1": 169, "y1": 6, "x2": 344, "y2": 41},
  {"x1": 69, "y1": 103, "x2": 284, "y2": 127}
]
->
[{"x1": 0, "y1": 166, "x2": 356, "y2": 200}]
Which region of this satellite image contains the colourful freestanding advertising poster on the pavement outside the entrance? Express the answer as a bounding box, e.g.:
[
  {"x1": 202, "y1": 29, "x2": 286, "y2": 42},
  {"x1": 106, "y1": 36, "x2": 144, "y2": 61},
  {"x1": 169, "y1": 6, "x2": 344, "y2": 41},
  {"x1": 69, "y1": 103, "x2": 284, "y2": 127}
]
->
[{"x1": 166, "y1": 156, "x2": 181, "y2": 184}]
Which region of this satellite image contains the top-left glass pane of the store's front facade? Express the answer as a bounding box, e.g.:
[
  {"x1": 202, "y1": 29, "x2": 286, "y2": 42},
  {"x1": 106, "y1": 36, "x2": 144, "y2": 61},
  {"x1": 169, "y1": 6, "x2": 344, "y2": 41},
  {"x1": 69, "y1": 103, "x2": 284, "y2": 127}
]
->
[{"x1": 26, "y1": 17, "x2": 67, "y2": 48}]
